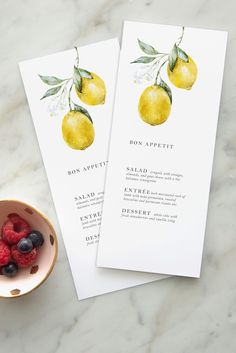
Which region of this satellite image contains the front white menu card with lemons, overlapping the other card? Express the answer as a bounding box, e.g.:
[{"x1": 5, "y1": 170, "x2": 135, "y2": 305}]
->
[{"x1": 97, "y1": 22, "x2": 227, "y2": 277}]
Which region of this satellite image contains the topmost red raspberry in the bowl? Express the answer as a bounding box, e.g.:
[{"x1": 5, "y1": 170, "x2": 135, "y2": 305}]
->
[{"x1": 2, "y1": 213, "x2": 30, "y2": 245}]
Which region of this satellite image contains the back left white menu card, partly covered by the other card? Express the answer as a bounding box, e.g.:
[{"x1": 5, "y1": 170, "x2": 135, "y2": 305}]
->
[{"x1": 20, "y1": 39, "x2": 163, "y2": 299}]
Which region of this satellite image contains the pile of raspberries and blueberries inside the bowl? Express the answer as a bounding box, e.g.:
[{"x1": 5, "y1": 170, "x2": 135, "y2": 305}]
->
[{"x1": 0, "y1": 213, "x2": 44, "y2": 277}]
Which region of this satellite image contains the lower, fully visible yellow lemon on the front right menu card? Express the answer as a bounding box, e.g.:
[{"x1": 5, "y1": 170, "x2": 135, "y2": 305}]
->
[{"x1": 138, "y1": 85, "x2": 171, "y2": 125}]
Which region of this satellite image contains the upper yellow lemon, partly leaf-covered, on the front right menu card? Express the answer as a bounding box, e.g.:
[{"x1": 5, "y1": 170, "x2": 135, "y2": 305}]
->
[{"x1": 167, "y1": 56, "x2": 197, "y2": 90}]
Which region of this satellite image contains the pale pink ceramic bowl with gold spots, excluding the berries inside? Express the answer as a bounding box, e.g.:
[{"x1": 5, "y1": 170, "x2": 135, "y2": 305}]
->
[{"x1": 0, "y1": 200, "x2": 58, "y2": 298}]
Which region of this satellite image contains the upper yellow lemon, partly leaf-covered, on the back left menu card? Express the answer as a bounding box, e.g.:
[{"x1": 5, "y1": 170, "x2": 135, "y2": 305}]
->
[{"x1": 76, "y1": 72, "x2": 106, "y2": 105}]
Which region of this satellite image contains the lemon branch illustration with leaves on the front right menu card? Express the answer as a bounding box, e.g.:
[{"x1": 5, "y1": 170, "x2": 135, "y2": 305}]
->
[{"x1": 131, "y1": 27, "x2": 198, "y2": 126}]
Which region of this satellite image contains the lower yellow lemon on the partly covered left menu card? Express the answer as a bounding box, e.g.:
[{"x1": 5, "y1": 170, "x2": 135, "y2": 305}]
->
[{"x1": 62, "y1": 110, "x2": 94, "y2": 150}]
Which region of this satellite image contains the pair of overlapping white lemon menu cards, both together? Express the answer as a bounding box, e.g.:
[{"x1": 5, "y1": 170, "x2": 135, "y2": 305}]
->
[{"x1": 20, "y1": 22, "x2": 227, "y2": 299}]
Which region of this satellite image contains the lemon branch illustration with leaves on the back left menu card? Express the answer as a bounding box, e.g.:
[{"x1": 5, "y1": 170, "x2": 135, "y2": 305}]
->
[{"x1": 39, "y1": 47, "x2": 106, "y2": 150}]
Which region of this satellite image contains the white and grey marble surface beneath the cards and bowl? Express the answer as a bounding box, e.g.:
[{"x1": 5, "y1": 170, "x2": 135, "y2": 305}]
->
[{"x1": 0, "y1": 0, "x2": 236, "y2": 353}]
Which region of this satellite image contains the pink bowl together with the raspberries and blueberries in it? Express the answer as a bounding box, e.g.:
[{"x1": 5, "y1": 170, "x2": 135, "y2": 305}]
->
[{"x1": 0, "y1": 200, "x2": 58, "y2": 298}]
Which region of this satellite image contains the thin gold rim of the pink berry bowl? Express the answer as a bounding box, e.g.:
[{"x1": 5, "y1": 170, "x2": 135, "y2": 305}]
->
[{"x1": 0, "y1": 199, "x2": 58, "y2": 299}]
